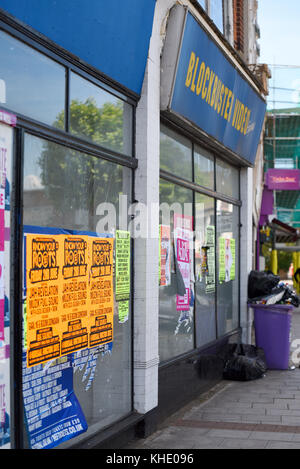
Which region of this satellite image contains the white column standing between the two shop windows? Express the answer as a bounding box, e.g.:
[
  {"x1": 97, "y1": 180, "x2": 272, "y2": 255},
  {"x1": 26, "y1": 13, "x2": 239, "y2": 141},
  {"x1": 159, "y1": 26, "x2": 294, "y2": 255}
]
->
[{"x1": 133, "y1": 4, "x2": 160, "y2": 414}]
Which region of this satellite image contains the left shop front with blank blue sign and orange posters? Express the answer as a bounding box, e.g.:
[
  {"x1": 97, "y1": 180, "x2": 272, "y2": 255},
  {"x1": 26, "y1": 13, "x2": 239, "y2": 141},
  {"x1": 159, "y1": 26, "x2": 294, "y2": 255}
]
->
[{"x1": 0, "y1": 0, "x2": 155, "y2": 449}]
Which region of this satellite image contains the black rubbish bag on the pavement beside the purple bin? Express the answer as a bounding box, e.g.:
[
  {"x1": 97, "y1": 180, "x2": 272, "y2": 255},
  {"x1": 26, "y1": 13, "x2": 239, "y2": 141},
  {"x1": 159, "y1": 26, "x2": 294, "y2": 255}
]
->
[{"x1": 223, "y1": 344, "x2": 267, "y2": 381}]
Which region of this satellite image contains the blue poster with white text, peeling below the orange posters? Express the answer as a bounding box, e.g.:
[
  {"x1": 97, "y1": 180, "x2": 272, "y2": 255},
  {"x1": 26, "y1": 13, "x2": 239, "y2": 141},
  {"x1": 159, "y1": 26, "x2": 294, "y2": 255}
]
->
[{"x1": 23, "y1": 353, "x2": 88, "y2": 449}]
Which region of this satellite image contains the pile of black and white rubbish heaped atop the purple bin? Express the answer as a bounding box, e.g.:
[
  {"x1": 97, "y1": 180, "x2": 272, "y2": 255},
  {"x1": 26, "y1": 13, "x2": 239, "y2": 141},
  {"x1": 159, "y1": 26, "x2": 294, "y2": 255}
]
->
[{"x1": 248, "y1": 270, "x2": 300, "y2": 308}]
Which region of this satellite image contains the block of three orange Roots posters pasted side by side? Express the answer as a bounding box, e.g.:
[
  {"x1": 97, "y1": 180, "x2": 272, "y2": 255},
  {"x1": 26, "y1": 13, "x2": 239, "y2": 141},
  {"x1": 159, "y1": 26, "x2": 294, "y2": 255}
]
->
[{"x1": 26, "y1": 234, "x2": 113, "y2": 366}]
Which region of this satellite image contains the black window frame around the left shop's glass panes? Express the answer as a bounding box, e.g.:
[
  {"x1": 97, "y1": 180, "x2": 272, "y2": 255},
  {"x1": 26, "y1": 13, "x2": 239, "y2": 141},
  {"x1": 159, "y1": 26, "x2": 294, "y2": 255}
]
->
[{"x1": 0, "y1": 13, "x2": 139, "y2": 449}]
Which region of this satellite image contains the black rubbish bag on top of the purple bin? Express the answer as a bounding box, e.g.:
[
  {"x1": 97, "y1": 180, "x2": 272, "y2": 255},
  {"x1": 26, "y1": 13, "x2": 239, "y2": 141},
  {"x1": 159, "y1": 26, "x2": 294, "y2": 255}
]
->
[{"x1": 248, "y1": 270, "x2": 280, "y2": 299}]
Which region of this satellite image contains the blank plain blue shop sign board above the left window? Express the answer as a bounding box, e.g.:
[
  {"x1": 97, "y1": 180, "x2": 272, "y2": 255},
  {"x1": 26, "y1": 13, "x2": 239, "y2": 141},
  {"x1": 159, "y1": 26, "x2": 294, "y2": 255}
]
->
[{"x1": 0, "y1": 0, "x2": 156, "y2": 95}]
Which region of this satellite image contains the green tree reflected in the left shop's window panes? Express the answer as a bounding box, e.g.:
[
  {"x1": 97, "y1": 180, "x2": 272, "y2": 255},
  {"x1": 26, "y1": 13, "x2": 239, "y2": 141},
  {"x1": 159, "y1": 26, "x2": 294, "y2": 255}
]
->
[{"x1": 39, "y1": 98, "x2": 123, "y2": 228}]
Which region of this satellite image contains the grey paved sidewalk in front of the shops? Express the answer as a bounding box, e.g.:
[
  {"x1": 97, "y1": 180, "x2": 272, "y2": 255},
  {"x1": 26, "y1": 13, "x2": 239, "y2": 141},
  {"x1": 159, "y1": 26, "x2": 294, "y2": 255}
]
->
[{"x1": 126, "y1": 308, "x2": 300, "y2": 449}]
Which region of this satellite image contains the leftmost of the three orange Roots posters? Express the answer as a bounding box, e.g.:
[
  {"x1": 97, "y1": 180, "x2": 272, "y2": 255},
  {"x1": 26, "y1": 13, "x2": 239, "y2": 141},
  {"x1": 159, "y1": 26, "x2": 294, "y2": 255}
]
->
[{"x1": 26, "y1": 235, "x2": 62, "y2": 366}]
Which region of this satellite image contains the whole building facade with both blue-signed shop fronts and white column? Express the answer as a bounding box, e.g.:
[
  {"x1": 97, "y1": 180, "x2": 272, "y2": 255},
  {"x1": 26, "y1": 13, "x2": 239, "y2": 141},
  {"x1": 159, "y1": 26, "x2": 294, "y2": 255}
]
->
[{"x1": 0, "y1": 0, "x2": 265, "y2": 449}]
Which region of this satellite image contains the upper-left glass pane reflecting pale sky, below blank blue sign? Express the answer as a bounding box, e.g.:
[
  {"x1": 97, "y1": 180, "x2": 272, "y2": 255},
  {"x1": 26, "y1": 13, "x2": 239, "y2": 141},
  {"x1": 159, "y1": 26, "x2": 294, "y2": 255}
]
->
[{"x1": 0, "y1": 31, "x2": 65, "y2": 129}]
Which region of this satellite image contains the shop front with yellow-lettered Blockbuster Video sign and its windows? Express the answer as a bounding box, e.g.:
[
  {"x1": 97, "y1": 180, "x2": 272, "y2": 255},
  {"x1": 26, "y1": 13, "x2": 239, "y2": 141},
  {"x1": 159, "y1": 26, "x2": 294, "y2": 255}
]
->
[{"x1": 158, "y1": 5, "x2": 265, "y2": 416}]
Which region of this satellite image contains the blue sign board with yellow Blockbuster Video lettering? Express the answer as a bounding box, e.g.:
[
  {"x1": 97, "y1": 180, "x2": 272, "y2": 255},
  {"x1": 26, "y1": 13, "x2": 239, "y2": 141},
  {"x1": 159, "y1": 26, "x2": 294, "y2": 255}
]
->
[{"x1": 162, "y1": 6, "x2": 266, "y2": 164}]
